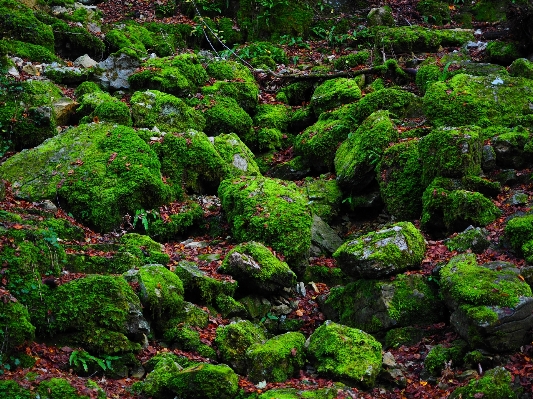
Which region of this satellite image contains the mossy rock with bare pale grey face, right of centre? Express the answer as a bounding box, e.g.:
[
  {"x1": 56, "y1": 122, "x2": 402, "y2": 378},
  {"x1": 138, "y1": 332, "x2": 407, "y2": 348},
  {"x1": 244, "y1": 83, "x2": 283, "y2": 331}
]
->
[{"x1": 333, "y1": 222, "x2": 426, "y2": 278}]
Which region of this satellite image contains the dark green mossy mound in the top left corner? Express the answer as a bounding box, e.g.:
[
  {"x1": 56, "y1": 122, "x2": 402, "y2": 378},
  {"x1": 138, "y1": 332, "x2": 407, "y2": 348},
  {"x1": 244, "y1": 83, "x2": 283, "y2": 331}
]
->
[{"x1": 0, "y1": 0, "x2": 54, "y2": 51}]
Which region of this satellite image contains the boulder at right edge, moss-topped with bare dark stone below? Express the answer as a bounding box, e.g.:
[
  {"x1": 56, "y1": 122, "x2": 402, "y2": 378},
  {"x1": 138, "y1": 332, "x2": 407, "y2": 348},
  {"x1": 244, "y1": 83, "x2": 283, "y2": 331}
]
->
[{"x1": 440, "y1": 254, "x2": 533, "y2": 352}]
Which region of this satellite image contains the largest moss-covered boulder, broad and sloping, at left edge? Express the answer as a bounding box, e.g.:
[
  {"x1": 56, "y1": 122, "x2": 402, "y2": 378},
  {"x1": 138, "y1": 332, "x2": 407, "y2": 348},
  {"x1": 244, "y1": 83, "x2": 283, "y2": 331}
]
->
[{"x1": 0, "y1": 123, "x2": 171, "y2": 231}]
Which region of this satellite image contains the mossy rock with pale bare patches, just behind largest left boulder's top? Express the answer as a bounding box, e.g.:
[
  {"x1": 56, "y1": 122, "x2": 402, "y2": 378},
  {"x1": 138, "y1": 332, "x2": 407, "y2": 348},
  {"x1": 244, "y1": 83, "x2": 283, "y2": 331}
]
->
[{"x1": 131, "y1": 90, "x2": 205, "y2": 132}]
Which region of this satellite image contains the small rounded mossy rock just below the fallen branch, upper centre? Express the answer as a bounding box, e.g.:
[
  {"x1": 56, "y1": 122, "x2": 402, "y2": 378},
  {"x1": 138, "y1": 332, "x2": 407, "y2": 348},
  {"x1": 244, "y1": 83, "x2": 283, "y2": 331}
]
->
[{"x1": 310, "y1": 78, "x2": 361, "y2": 116}]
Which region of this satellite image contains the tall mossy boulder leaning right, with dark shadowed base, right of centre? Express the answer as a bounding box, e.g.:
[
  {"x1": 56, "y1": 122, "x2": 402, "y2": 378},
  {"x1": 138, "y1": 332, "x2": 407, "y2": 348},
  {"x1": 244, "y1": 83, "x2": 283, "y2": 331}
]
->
[{"x1": 335, "y1": 110, "x2": 398, "y2": 191}]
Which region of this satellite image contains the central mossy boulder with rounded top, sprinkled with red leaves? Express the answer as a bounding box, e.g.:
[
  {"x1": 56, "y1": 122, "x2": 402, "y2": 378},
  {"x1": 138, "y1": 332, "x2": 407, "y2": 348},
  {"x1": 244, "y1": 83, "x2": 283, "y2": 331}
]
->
[{"x1": 218, "y1": 177, "x2": 312, "y2": 273}]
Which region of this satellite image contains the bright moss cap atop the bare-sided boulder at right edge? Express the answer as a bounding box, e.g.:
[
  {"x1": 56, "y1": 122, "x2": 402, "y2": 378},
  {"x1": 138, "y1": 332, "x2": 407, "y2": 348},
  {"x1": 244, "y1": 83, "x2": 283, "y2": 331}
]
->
[{"x1": 440, "y1": 254, "x2": 531, "y2": 308}]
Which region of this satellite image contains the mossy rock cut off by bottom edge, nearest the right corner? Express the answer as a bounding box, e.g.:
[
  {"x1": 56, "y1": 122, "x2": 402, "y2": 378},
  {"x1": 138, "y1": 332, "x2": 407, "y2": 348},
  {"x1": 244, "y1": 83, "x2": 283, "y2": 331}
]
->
[{"x1": 450, "y1": 367, "x2": 518, "y2": 399}]
